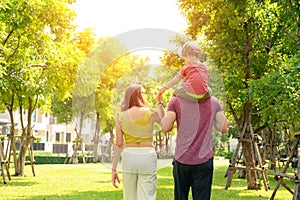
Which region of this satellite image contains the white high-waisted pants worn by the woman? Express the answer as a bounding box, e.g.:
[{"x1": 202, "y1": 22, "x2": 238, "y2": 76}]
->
[{"x1": 122, "y1": 147, "x2": 157, "y2": 200}]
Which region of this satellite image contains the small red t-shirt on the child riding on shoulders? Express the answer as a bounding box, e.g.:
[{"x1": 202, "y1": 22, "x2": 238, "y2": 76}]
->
[{"x1": 177, "y1": 63, "x2": 209, "y2": 95}]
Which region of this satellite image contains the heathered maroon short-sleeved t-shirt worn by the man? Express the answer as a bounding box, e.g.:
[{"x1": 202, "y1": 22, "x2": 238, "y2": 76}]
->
[{"x1": 167, "y1": 96, "x2": 222, "y2": 165}]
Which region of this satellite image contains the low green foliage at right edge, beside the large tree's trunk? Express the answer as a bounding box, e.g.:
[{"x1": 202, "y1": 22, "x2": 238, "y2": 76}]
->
[{"x1": 253, "y1": 50, "x2": 300, "y2": 132}]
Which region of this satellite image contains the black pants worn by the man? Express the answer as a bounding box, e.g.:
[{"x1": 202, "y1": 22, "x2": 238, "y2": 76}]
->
[{"x1": 172, "y1": 158, "x2": 214, "y2": 200}]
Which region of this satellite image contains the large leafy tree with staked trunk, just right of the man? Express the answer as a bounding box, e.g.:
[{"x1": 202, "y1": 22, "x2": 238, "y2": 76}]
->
[{"x1": 180, "y1": 0, "x2": 299, "y2": 189}]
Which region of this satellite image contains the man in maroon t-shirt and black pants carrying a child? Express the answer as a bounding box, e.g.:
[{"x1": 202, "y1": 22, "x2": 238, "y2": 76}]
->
[{"x1": 157, "y1": 96, "x2": 228, "y2": 200}]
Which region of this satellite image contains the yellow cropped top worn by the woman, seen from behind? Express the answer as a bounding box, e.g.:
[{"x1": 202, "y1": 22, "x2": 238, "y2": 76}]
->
[{"x1": 118, "y1": 108, "x2": 157, "y2": 144}]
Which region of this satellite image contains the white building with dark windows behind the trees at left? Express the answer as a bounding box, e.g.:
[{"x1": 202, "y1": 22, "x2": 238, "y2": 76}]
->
[{"x1": 0, "y1": 109, "x2": 109, "y2": 155}]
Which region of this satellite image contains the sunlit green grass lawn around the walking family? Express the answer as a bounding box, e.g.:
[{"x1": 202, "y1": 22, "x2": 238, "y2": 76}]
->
[{"x1": 0, "y1": 159, "x2": 294, "y2": 200}]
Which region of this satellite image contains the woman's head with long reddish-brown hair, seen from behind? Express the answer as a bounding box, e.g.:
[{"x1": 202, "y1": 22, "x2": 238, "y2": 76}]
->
[{"x1": 121, "y1": 84, "x2": 146, "y2": 111}]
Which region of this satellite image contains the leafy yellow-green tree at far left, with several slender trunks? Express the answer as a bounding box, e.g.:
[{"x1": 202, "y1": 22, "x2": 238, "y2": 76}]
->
[{"x1": 0, "y1": 0, "x2": 82, "y2": 176}]
